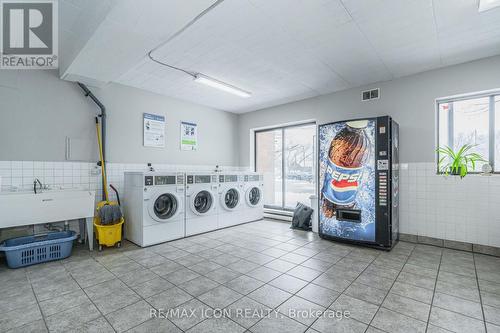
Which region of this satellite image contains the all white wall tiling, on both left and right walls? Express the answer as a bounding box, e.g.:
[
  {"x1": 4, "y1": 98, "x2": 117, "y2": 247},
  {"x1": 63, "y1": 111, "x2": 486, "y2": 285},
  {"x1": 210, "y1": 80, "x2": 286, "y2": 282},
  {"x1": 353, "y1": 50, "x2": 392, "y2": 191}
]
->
[{"x1": 0, "y1": 161, "x2": 500, "y2": 247}]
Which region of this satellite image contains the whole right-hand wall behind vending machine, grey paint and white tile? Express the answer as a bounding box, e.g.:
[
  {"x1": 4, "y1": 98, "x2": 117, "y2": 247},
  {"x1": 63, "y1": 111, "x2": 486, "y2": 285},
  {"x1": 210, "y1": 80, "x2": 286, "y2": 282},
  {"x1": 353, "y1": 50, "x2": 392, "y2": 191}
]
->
[{"x1": 239, "y1": 56, "x2": 500, "y2": 247}]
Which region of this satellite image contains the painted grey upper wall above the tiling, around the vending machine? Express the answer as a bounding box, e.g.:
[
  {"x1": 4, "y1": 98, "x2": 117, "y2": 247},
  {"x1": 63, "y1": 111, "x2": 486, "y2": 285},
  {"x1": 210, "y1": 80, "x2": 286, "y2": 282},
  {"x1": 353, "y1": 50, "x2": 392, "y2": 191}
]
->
[{"x1": 239, "y1": 56, "x2": 500, "y2": 166}]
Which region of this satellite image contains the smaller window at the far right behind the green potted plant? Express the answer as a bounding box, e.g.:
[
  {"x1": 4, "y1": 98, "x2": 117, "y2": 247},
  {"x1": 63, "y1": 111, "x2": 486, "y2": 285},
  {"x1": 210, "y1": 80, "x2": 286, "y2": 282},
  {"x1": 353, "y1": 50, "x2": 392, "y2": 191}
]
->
[{"x1": 438, "y1": 92, "x2": 500, "y2": 172}]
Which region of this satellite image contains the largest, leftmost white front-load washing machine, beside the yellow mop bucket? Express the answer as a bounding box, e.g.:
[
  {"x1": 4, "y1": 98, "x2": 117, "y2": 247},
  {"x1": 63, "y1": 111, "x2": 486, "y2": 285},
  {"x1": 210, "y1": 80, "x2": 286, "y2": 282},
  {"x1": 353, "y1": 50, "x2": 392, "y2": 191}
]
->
[{"x1": 123, "y1": 172, "x2": 185, "y2": 246}]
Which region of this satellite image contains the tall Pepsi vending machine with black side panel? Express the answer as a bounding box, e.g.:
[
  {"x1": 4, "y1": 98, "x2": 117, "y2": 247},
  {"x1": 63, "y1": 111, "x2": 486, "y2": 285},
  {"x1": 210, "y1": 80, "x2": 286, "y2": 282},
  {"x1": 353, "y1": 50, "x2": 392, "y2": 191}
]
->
[{"x1": 318, "y1": 116, "x2": 399, "y2": 250}]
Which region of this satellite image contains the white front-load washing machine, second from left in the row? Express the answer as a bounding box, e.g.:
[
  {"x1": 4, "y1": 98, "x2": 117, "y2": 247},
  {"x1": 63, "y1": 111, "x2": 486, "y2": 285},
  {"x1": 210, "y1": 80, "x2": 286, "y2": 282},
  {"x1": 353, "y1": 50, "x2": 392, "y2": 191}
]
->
[{"x1": 186, "y1": 172, "x2": 219, "y2": 236}]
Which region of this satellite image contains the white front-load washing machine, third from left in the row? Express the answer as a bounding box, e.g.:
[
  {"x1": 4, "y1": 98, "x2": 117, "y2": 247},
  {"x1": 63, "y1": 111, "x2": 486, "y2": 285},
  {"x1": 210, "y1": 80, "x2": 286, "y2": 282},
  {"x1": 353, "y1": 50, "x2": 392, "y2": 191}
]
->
[{"x1": 218, "y1": 173, "x2": 245, "y2": 228}]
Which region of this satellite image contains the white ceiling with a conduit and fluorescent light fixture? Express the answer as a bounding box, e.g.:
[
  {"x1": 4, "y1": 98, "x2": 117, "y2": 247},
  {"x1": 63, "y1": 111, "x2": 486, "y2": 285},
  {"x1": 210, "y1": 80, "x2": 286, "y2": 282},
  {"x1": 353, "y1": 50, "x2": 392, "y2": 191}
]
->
[{"x1": 59, "y1": 0, "x2": 500, "y2": 113}]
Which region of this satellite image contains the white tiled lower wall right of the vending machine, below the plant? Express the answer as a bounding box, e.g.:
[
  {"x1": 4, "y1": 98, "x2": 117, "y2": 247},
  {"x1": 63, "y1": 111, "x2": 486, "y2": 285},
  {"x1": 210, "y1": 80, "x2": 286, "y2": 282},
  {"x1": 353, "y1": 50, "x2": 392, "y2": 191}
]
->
[{"x1": 400, "y1": 163, "x2": 500, "y2": 247}]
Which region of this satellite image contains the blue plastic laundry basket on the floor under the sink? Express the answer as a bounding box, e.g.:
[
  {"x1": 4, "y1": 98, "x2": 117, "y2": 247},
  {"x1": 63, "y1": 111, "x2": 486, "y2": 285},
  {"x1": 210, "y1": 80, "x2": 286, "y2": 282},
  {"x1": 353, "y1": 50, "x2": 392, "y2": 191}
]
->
[{"x1": 0, "y1": 231, "x2": 77, "y2": 268}]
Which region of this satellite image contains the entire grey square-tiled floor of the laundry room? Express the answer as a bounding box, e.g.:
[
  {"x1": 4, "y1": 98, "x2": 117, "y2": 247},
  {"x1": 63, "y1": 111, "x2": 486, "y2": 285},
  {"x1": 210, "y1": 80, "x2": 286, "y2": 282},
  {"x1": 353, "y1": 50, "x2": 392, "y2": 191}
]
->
[{"x1": 0, "y1": 221, "x2": 500, "y2": 333}]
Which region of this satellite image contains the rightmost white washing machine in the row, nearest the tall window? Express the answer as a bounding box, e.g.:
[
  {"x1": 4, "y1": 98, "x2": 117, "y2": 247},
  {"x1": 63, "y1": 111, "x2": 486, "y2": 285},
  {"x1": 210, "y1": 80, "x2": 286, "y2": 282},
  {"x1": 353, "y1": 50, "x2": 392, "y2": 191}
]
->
[{"x1": 243, "y1": 172, "x2": 264, "y2": 222}]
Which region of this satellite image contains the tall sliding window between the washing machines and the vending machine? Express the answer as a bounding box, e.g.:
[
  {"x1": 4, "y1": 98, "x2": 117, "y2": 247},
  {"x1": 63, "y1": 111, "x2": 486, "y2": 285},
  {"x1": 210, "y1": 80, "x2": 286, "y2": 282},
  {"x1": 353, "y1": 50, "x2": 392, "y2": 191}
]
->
[{"x1": 255, "y1": 124, "x2": 316, "y2": 209}]
